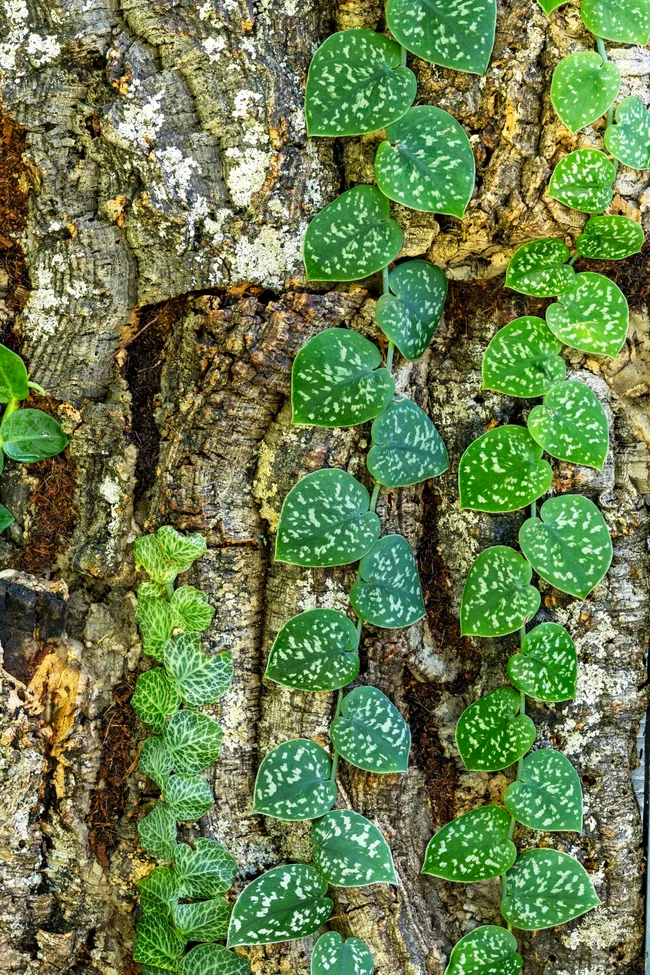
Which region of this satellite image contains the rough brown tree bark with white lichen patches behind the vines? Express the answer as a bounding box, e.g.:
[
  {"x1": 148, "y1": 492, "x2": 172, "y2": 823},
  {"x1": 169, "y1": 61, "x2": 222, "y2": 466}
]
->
[{"x1": 0, "y1": 0, "x2": 650, "y2": 975}]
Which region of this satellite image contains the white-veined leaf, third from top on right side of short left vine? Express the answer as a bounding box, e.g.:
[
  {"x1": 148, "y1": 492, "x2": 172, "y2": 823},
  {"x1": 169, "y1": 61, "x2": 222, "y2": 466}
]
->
[{"x1": 162, "y1": 633, "x2": 233, "y2": 708}]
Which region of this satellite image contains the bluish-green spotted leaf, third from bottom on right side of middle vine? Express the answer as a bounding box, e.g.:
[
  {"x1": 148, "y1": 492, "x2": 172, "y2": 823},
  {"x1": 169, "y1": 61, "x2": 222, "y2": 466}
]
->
[{"x1": 330, "y1": 687, "x2": 411, "y2": 773}]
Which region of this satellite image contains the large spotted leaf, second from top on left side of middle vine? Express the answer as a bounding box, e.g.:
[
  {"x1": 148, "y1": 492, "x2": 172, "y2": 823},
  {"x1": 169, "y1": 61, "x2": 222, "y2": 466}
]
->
[{"x1": 303, "y1": 186, "x2": 403, "y2": 281}]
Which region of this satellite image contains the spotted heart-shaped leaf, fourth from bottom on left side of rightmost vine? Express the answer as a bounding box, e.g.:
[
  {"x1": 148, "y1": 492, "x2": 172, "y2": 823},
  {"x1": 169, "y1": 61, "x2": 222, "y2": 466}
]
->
[{"x1": 460, "y1": 545, "x2": 541, "y2": 636}]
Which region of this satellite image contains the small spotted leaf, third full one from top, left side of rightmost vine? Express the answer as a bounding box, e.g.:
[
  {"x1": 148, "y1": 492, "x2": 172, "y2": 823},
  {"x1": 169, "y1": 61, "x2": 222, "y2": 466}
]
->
[{"x1": 506, "y1": 237, "x2": 575, "y2": 298}]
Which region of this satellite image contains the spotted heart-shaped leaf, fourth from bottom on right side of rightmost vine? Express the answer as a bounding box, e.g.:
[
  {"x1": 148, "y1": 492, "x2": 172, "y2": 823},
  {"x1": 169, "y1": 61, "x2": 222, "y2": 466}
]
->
[{"x1": 519, "y1": 494, "x2": 612, "y2": 599}]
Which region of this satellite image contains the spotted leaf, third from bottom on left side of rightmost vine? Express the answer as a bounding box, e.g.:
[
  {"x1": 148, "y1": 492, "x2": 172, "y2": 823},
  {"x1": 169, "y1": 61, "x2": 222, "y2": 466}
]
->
[{"x1": 456, "y1": 687, "x2": 536, "y2": 772}]
